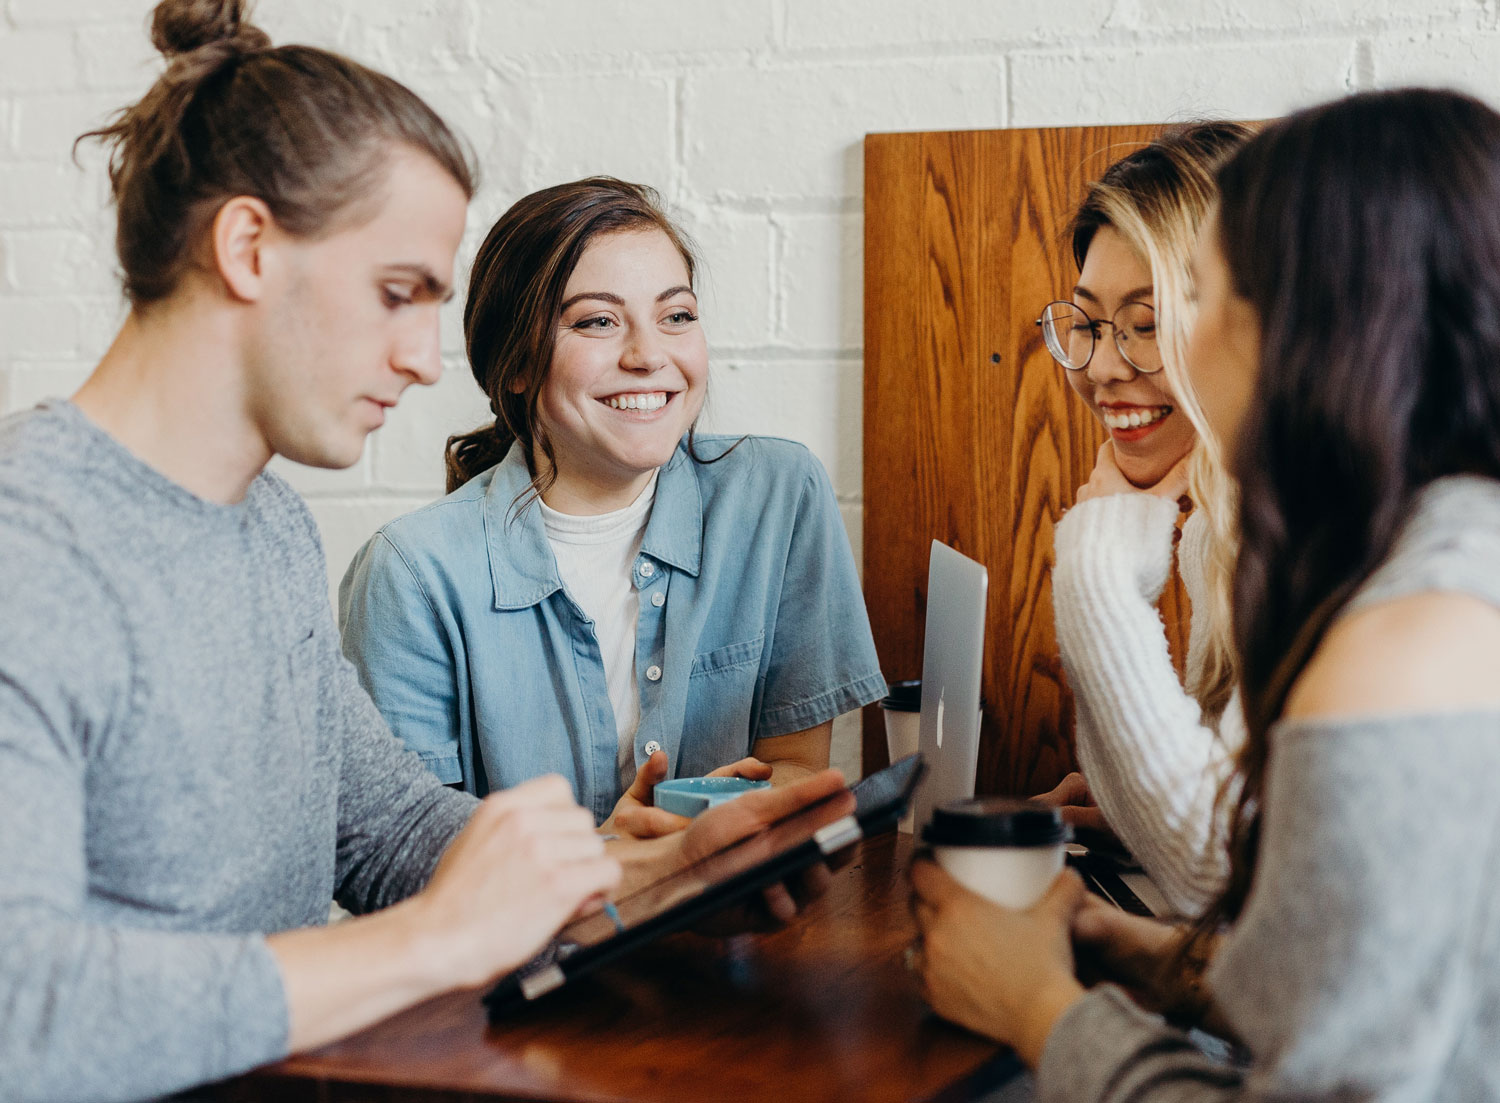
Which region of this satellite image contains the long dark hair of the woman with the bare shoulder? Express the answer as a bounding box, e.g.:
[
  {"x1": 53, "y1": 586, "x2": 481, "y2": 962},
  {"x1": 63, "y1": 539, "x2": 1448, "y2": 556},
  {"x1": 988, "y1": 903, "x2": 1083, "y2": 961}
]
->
[{"x1": 1196, "y1": 89, "x2": 1500, "y2": 941}]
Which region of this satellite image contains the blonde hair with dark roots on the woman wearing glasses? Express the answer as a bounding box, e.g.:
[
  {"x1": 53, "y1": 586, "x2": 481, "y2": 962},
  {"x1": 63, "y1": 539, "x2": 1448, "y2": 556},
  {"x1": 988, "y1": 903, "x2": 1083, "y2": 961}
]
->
[{"x1": 1073, "y1": 122, "x2": 1253, "y2": 725}]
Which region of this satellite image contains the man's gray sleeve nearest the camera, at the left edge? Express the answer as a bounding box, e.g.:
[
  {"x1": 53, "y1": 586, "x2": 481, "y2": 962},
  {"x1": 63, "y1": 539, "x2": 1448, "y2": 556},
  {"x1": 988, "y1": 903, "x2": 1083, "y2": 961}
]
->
[{"x1": 0, "y1": 525, "x2": 288, "y2": 1100}]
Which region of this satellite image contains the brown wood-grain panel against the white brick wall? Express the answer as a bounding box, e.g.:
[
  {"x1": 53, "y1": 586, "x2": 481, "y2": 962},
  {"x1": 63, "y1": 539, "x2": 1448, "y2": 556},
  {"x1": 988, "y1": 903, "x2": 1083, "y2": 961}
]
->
[{"x1": 864, "y1": 126, "x2": 1187, "y2": 794}]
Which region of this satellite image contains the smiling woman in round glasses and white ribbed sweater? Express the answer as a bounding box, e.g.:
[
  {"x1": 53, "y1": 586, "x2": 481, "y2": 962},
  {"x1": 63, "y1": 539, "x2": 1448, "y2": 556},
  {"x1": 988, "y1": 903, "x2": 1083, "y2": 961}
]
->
[{"x1": 1038, "y1": 123, "x2": 1250, "y2": 914}]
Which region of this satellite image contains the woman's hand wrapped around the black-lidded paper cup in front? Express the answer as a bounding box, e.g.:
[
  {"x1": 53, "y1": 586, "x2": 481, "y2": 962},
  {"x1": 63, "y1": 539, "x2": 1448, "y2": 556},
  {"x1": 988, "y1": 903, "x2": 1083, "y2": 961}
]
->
[{"x1": 912, "y1": 858, "x2": 1085, "y2": 1068}]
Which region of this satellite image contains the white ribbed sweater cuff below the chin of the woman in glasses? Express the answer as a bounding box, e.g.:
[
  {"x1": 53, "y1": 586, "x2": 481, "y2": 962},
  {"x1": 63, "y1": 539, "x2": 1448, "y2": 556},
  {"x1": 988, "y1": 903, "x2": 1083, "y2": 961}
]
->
[{"x1": 1053, "y1": 494, "x2": 1178, "y2": 602}]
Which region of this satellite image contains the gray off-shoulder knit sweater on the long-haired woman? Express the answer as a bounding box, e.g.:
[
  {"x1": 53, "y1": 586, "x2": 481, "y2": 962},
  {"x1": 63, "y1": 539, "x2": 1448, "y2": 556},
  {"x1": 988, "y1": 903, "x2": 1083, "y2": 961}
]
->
[{"x1": 1038, "y1": 477, "x2": 1500, "y2": 1103}]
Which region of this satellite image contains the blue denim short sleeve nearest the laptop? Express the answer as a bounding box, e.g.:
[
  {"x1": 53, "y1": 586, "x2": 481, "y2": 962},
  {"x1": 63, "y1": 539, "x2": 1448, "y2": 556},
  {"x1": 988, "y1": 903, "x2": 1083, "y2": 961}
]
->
[{"x1": 750, "y1": 449, "x2": 887, "y2": 741}]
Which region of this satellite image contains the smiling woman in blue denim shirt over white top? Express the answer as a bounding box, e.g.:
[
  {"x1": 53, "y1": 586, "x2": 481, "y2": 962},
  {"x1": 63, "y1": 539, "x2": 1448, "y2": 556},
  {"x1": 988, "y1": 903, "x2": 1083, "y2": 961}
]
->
[{"x1": 341, "y1": 177, "x2": 885, "y2": 834}]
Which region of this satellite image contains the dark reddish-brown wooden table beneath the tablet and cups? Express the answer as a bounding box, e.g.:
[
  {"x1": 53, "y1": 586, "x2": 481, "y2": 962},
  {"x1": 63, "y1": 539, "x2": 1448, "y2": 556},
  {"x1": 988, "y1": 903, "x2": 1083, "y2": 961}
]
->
[{"x1": 205, "y1": 834, "x2": 1016, "y2": 1103}]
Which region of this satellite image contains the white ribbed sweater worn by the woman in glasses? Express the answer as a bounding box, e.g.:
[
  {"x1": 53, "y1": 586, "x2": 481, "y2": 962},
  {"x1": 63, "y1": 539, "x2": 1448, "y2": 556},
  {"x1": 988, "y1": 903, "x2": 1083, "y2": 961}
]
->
[{"x1": 1052, "y1": 494, "x2": 1245, "y2": 915}]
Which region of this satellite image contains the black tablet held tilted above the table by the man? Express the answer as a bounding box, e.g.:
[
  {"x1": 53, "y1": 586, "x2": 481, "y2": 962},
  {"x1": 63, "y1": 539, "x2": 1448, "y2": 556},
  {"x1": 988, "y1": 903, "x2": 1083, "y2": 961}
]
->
[{"x1": 485, "y1": 755, "x2": 924, "y2": 1020}]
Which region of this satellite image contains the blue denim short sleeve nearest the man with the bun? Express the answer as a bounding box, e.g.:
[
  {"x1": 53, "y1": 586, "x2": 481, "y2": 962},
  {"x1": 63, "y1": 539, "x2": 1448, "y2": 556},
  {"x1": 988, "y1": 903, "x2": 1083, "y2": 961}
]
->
[{"x1": 339, "y1": 533, "x2": 473, "y2": 785}]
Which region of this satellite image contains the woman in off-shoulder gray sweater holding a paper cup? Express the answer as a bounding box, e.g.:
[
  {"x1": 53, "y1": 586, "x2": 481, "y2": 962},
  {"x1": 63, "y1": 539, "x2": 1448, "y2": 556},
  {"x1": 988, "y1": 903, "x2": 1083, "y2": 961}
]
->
[{"x1": 914, "y1": 90, "x2": 1500, "y2": 1101}]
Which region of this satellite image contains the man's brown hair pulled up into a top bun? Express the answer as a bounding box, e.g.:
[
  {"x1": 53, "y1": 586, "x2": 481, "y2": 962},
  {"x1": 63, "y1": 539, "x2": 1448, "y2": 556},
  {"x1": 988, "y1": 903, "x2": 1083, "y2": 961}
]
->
[{"x1": 78, "y1": 0, "x2": 474, "y2": 308}]
